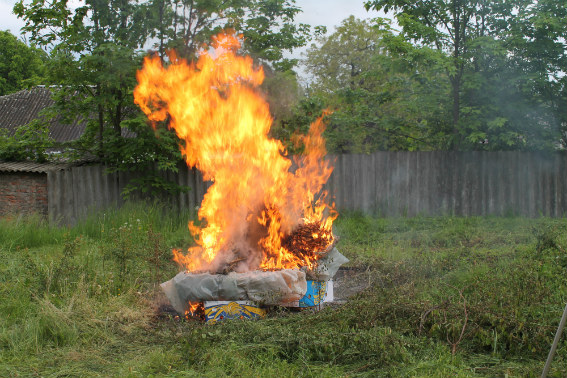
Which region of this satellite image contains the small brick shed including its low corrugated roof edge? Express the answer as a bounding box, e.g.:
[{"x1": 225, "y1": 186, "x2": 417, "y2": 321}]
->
[{"x1": 0, "y1": 162, "x2": 71, "y2": 216}]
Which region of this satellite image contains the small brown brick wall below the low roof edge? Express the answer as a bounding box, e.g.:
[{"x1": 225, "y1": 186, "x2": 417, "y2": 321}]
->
[{"x1": 0, "y1": 172, "x2": 47, "y2": 216}]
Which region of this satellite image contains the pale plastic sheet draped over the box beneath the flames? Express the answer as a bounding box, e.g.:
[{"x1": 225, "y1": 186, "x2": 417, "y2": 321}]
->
[{"x1": 161, "y1": 269, "x2": 308, "y2": 314}]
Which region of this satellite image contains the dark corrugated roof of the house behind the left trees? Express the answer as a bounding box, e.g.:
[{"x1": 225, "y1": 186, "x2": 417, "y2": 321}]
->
[{"x1": 0, "y1": 87, "x2": 86, "y2": 142}]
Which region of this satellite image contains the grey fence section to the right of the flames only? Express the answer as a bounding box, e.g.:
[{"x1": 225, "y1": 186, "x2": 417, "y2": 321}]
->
[{"x1": 328, "y1": 152, "x2": 567, "y2": 217}]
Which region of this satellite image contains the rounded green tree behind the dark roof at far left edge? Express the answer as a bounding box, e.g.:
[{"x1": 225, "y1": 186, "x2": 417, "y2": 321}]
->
[{"x1": 0, "y1": 31, "x2": 47, "y2": 96}]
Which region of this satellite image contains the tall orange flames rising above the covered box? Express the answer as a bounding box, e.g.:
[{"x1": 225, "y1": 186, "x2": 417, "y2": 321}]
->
[{"x1": 134, "y1": 32, "x2": 336, "y2": 271}]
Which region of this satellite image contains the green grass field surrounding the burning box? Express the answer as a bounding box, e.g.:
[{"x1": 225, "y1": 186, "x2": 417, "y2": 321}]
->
[{"x1": 0, "y1": 205, "x2": 567, "y2": 378}]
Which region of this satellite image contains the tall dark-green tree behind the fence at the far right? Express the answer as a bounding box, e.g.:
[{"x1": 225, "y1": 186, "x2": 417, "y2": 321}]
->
[{"x1": 365, "y1": 0, "x2": 567, "y2": 149}]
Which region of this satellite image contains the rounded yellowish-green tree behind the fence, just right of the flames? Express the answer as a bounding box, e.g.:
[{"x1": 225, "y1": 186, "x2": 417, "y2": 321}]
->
[{"x1": 296, "y1": 16, "x2": 446, "y2": 152}]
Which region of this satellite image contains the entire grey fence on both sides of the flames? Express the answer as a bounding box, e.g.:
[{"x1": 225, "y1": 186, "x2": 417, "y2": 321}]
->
[{"x1": 48, "y1": 152, "x2": 567, "y2": 224}]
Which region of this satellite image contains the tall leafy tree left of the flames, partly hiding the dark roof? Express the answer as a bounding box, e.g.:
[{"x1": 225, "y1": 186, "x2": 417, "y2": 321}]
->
[{"x1": 14, "y1": 0, "x2": 155, "y2": 153}]
